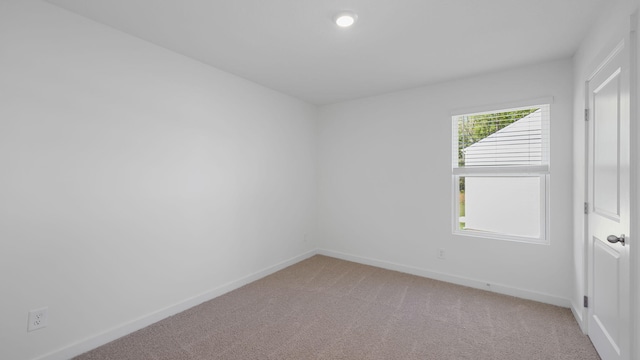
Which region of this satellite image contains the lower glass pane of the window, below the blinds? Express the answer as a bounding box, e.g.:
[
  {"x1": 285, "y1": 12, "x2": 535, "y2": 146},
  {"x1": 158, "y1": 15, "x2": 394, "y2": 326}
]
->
[{"x1": 458, "y1": 176, "x2": 544, "y2": 238}]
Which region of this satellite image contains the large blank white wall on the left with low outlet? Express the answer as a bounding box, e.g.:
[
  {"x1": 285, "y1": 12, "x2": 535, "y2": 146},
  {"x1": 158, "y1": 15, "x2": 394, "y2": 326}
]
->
[{"x1": 0, "y1": 0, "x2": 317, "y2": 360}]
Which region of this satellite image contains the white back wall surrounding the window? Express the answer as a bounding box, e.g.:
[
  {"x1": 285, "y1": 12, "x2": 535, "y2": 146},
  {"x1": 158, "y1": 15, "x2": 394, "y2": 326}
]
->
[{"x1": 318, "y1": 60, "x2": 573, "y2": 306}]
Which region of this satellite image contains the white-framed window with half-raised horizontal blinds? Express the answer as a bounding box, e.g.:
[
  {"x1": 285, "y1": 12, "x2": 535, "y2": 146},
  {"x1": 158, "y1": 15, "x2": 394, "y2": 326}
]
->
[{"x1": 452, "y1": 99, "x2": 551, "y2": 243}]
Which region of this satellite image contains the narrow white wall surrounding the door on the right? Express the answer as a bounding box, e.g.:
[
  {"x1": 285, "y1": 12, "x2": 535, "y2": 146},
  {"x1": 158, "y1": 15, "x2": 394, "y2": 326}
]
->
[{"x1": 571, "y1": 0, "x2": 640, "y2": 326}]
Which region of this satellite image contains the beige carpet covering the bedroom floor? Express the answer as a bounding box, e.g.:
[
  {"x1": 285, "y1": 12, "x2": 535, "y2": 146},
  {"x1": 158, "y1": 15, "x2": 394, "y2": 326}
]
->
[{"x1": 76, "y1": 256, "x2": 599, "y2": 360}]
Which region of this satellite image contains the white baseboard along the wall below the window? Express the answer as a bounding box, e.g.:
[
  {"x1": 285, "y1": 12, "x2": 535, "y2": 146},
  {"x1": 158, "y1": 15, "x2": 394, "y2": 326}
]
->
[{"x1": 317, "y1": 249, "x2": 571, "y2": 308}]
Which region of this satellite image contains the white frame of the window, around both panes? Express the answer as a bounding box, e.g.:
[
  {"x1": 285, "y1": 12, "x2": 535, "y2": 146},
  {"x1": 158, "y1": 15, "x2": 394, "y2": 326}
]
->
[{"x1": 450, "y1": 97, "x2": 553, "y2": 245}]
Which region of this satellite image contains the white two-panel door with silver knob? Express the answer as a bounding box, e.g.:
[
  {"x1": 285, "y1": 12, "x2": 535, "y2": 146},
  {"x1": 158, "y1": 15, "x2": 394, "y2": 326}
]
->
[{"x1": 587, "y1": 40, "x2": 631, "y2": 360}]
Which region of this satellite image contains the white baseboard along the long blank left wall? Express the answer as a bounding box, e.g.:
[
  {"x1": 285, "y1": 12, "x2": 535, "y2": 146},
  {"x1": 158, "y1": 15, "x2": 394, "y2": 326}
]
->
[{"x1": 34, "y1": 250, "x2": 316, "y2": 360}]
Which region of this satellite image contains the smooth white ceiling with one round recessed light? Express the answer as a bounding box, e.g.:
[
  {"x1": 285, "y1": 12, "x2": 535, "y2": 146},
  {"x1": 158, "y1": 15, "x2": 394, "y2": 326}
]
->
[{"x1": 49, "y1": 0, "x2": 610, "y2": 104}]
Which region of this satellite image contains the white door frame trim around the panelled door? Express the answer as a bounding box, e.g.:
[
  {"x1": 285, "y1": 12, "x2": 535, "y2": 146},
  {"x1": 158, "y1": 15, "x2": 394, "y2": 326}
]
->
[{"x1": 581, "y1": 12, "x2": 640, "y2": 359}]
